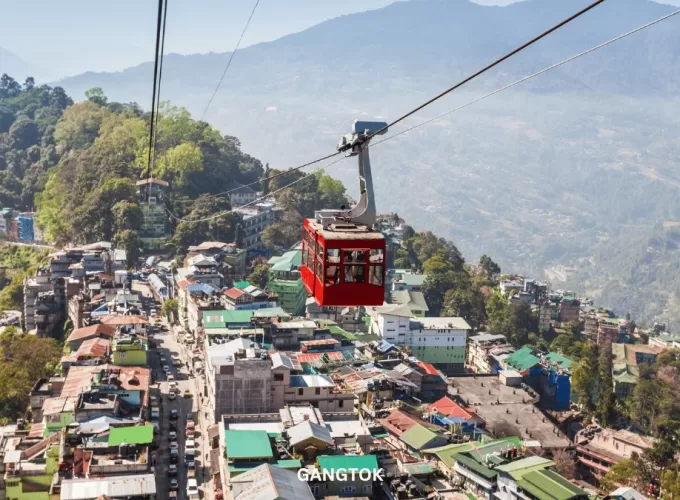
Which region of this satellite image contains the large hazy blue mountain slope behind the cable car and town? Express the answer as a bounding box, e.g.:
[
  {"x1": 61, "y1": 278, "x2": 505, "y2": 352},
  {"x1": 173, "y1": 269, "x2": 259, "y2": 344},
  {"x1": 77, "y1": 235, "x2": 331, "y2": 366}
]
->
[{"x1": 59, "y1": 0, "x2": 680, "y2": 326}]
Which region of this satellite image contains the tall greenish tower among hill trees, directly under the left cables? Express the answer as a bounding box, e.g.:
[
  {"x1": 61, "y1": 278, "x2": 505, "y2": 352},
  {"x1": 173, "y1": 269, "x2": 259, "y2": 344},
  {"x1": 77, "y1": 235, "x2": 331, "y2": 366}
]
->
[{"x1": 137, "y1": 178, "x2": 171, "y2": 249}]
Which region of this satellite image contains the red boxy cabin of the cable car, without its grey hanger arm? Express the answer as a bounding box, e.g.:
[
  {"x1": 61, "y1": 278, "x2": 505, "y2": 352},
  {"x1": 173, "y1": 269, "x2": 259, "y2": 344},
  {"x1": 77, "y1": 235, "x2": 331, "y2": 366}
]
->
[{"x1": 300, "y1": 219, "x2": 385, "y2": 307}]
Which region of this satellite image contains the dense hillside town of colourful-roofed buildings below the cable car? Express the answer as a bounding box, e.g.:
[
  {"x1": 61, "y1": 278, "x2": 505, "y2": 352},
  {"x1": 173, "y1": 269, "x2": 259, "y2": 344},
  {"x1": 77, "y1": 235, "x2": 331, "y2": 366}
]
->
[{"x1": 0, "y1": 208, "x2": 680, "y2": 500}]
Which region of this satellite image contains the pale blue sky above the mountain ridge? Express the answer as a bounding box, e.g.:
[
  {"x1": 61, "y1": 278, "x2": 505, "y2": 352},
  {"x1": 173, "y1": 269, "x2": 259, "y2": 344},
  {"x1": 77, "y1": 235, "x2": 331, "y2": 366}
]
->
[{"x1": 0, "y1": 0, "x2": 680, "y2": 79}]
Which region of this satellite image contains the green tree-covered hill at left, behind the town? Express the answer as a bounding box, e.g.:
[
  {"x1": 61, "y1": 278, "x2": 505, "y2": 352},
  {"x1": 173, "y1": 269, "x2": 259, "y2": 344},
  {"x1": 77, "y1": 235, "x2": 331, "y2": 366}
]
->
[{"x1": 0, "y1": 75, "x2": 354, "y2": 254}]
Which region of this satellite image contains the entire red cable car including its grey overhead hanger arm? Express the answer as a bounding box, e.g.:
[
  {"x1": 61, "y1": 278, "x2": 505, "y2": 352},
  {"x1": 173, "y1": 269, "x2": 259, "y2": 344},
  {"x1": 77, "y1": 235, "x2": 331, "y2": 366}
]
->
[{"x1": 300, "y1": 121, "x2": 387, "y2": 307}]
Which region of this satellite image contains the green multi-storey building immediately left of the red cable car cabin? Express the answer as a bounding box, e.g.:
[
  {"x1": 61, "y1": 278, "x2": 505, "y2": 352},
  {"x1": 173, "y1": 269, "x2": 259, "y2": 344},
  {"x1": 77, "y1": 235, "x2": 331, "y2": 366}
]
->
[{"x1": 267, "y1": 249, "x2": 307, "y2": 316}]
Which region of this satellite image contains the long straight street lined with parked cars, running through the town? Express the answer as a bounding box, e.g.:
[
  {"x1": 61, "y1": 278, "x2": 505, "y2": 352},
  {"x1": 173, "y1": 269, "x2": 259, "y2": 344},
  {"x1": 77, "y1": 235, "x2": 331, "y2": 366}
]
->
[{"x1": 132, "y1": 281, "x2": 213, "y2": 500}]
